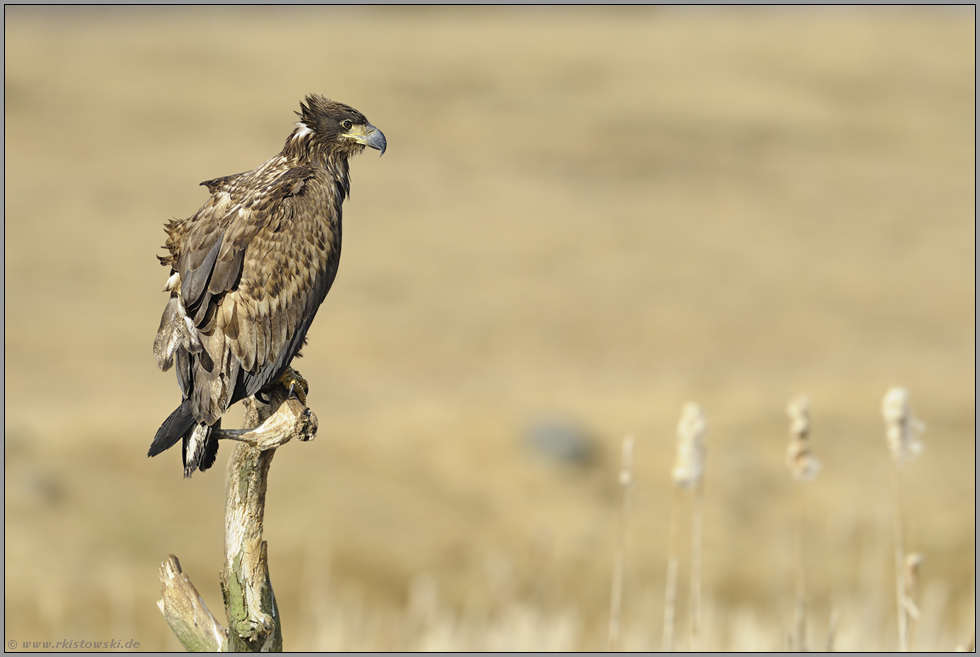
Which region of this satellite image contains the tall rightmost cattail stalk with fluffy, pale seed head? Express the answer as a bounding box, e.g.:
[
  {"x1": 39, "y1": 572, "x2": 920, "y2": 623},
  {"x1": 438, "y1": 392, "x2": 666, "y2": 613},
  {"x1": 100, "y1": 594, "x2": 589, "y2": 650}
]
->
[{"x1": 881, "y1": 387, "x2": 925, "y2": 652}]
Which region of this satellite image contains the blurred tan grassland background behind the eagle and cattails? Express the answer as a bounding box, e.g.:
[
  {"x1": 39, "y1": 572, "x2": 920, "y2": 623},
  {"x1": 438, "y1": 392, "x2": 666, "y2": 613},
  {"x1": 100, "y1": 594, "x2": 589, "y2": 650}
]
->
[{"x1": 4, "y1": 7, "x2": 976, "y2": 650}]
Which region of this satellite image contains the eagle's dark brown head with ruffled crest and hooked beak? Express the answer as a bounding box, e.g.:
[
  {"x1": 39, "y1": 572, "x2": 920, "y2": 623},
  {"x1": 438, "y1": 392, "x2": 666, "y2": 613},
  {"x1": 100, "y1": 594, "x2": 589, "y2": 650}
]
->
[{"x1": 292, "y1": 94, "x2": 387, "y2": 157}]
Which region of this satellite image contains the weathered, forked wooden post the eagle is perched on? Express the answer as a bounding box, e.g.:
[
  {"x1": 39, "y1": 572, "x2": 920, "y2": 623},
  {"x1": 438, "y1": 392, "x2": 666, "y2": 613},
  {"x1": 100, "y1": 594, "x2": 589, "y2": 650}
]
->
[{"x1": 157, "y1": 376, "x2": 317, "y2": 652}]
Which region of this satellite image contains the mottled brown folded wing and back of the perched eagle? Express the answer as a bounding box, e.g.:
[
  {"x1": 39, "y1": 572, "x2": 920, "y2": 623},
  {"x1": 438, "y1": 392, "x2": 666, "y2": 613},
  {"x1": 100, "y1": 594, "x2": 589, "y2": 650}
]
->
[{"x1": 155, "y1": 166, "x2": 340, "y2": 425}]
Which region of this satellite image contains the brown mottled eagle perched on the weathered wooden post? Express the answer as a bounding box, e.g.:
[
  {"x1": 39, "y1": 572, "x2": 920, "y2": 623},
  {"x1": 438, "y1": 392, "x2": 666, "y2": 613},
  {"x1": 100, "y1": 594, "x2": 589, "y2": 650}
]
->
[{"x1": 147, "y1": 94, "x2": 387, "y2": 478}]
